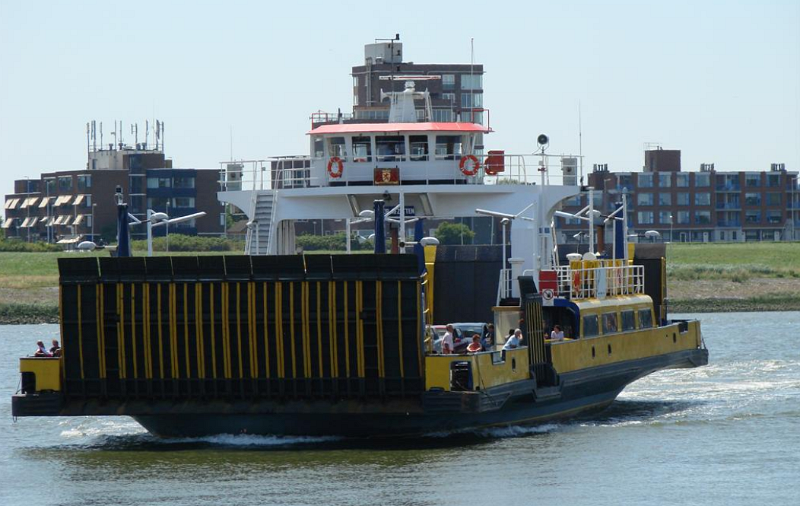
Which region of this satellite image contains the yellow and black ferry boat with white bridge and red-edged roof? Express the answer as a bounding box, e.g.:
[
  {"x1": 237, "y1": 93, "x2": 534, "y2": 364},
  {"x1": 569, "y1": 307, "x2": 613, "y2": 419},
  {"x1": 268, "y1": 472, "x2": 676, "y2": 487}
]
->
[{"x1": 12, "y1": 83, "x2": 708, "y2": 437}]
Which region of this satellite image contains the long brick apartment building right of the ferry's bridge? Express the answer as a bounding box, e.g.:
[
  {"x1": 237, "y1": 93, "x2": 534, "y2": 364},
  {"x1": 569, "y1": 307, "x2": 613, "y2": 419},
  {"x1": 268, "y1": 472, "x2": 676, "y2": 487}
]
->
[{"x1": 557, "y1": 149, "x2": 800, "y2": 243}]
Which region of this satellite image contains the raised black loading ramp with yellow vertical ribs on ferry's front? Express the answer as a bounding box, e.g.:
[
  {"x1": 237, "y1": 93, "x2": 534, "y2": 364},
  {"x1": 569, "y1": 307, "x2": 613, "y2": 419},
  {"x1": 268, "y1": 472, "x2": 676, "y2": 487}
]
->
[{"x1": 59, "y1": 255, "x2": 424, "y2": 401}]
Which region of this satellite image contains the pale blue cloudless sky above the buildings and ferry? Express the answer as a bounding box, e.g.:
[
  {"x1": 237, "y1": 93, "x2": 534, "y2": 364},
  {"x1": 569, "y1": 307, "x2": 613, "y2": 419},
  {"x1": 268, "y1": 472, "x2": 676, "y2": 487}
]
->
[{"x1": 0, "y1": 0, "x2": 800, "y2": 194}]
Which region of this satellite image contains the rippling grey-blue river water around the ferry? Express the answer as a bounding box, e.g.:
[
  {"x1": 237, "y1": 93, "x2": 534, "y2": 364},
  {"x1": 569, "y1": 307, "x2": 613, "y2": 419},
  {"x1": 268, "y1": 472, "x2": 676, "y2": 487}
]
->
[{"x1": 0, "y1": 312, "x2": 800, "y2": 506}]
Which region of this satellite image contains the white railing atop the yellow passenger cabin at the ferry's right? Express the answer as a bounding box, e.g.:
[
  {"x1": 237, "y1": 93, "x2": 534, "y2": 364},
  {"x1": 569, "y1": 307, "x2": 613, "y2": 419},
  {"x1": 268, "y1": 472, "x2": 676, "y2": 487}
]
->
[{"x1": 557, "y1": 260, "x2": 644, "y2": 299}]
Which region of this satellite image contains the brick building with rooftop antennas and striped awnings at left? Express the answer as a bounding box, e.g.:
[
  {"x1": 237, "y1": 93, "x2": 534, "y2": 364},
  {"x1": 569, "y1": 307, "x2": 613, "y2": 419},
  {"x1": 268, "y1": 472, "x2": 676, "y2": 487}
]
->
[{"x1": 0, "y1": 127, "x2": 225, "y2": 243}]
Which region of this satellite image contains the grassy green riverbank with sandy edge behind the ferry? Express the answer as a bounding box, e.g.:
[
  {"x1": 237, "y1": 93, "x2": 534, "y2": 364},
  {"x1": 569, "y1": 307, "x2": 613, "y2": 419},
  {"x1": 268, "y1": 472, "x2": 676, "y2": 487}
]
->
[{"x1": 0, "y1": 243, "x2": 800, "y2": 324}]
